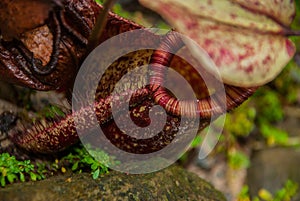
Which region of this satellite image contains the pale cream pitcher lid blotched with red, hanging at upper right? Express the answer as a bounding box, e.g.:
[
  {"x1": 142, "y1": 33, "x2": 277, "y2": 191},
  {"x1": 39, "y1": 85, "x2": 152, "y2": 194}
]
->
[{"x1": 140, "y1": 0, "x2": 295, "y2": 87}]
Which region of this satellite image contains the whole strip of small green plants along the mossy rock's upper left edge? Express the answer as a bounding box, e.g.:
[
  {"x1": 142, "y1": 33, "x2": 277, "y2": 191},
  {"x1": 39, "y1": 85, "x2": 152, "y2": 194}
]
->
[{"x1": 0, "y1": 146, "x2": 117, "y2": 187}]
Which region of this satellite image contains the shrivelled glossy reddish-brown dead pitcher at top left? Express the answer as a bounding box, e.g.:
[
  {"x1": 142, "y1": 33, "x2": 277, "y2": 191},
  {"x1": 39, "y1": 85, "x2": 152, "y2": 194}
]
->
[{"x1": 0, "y1": 0, "x2": 145, "y2": 90}]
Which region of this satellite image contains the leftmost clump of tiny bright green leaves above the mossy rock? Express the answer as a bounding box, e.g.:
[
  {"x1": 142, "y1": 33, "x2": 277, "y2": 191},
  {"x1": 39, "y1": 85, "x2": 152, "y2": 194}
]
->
[{"x1": 0, "y1": 153, "x2": 45, "y2": 187}]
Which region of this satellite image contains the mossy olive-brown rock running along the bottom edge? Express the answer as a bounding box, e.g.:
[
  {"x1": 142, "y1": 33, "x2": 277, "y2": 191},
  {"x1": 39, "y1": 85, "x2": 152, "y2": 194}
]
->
[{"x1": 0, "y1": 166, "x2": 225, "y2": 201}]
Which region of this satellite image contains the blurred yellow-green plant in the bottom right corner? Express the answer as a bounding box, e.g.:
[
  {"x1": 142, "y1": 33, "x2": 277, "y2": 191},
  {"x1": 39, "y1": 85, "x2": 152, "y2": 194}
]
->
[{"x1": 238, "y1": 180, "x2": 298, "y2": 201}]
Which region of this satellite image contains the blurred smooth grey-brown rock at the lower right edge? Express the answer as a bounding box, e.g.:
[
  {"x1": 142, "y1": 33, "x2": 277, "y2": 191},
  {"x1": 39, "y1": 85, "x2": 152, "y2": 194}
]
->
[{"x1": 247, "y1": 147, "x2": 300, "y2": 200}]
